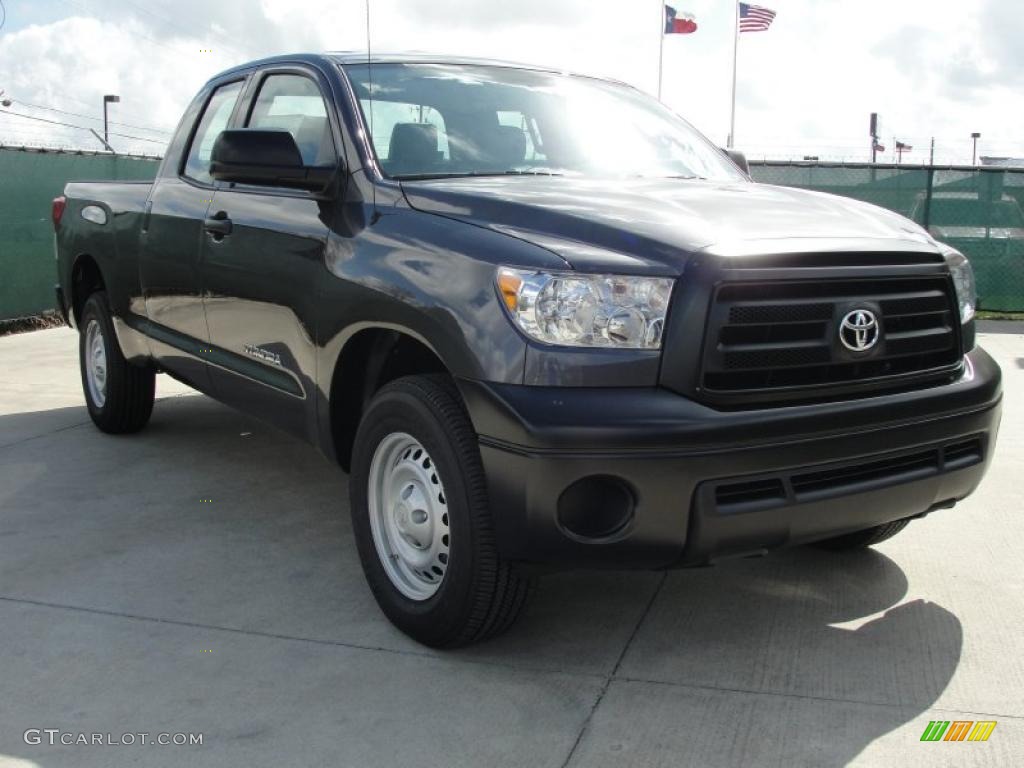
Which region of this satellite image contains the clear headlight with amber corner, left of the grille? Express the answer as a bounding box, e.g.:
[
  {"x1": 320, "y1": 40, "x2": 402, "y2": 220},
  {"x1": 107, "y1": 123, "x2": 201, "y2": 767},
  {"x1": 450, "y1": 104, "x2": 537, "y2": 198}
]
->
[{"x1": 498, "y1": 267, "x2": 674, "y2": 349}]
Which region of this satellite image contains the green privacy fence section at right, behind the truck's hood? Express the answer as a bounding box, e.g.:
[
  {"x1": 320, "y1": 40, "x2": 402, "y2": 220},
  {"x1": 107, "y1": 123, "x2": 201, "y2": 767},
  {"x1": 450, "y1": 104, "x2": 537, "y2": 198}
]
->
[{"x1": 751, "y1": 161, "x2": 1024, "y2": 311}]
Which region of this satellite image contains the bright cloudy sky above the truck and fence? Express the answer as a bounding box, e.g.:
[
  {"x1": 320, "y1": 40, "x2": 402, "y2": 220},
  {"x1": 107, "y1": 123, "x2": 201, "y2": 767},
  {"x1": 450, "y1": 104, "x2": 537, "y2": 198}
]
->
[{"x1": 0, "y1": 0, "x2": 1024, "y2": 164}]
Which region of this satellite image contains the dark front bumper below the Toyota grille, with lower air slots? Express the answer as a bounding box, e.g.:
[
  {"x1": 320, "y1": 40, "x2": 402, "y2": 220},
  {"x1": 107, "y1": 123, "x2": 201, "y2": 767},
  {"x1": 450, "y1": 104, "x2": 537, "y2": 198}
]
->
[{"x1": 460, "y1": 349, "x2": 1001, "y2": 568}]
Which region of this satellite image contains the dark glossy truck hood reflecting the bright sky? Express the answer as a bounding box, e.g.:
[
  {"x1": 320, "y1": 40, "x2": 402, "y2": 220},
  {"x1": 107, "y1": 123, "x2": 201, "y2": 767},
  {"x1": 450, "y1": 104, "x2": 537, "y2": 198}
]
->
[{"x1": 402, "y1": 176, "x2": 937, "y2": 274}]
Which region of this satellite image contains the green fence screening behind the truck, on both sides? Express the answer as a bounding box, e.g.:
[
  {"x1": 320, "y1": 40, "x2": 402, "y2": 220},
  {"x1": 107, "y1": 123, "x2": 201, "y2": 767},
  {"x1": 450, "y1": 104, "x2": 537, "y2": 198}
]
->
[{"x1": 0, "y1": 147, "x2": 1024, "y2": 319}]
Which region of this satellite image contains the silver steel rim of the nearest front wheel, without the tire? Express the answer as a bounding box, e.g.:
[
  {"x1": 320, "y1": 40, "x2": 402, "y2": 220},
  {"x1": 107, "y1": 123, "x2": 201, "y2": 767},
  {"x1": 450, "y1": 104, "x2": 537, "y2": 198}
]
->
[{"x1": 367, "y1": 432, "x2": 451, "y2": 601}]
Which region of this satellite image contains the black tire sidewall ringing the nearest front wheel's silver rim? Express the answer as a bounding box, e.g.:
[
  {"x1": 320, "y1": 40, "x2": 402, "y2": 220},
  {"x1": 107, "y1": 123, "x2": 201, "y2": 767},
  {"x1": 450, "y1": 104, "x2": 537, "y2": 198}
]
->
[{"x1": 349, "y1": 382, "x2": 479, "y2": 644}]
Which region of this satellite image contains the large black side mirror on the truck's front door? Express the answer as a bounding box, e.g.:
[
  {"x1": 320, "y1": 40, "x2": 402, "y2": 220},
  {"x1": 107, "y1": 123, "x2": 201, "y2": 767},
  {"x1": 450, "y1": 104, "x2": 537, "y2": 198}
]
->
[{"x1": 210, "y1": 128, "x2": 337, "y2": 193}]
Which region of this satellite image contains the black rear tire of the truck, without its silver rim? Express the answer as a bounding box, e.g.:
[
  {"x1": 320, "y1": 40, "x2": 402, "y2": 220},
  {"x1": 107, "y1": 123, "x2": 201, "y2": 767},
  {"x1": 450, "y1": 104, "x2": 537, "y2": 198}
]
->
[{"x1": 78, "y1": 291, "x2": 157, "y2": 434}]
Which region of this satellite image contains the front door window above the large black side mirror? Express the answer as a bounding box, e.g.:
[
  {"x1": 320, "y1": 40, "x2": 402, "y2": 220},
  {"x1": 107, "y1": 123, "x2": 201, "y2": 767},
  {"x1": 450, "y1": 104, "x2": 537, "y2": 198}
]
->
[{"x1": 247, "y1": 75, "x2": 338, "y2": 167}]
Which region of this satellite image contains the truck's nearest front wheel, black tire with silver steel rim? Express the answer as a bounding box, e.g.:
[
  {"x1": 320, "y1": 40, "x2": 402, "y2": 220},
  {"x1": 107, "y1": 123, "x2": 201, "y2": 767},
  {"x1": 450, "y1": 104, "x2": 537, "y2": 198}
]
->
[{"x1": 349, "y1": 376, "x2": 529, "y2": 647}]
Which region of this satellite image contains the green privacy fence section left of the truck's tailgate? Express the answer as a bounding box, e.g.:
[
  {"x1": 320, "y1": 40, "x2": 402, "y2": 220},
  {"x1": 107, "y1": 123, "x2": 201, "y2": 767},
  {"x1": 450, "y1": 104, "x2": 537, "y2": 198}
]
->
[{"x1": 0, "y1": 146, "x2": 160, "y2": 319}]
